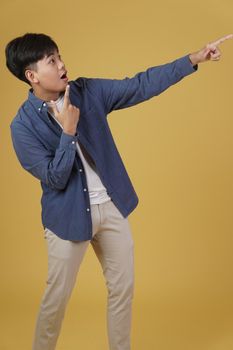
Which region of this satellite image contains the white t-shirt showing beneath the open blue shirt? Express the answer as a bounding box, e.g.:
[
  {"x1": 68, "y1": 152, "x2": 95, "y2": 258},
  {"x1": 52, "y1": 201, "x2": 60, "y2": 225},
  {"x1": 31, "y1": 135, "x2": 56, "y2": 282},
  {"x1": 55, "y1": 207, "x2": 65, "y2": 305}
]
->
[{"x1": 46, "y1": 94, "x2": 111, "y2": 204}]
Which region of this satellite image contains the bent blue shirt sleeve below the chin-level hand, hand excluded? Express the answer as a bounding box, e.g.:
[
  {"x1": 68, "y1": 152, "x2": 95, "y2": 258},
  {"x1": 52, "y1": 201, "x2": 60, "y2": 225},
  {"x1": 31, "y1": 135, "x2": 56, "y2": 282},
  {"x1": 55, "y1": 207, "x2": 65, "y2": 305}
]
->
[{"x1": 10, "y1": 122, "x2": 77, "y2": 190}]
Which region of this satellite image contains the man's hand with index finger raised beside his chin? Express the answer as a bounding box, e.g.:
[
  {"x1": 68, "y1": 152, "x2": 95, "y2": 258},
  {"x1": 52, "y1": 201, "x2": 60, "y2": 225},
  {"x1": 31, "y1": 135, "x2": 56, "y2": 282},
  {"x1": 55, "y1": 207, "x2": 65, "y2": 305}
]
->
[{"x1": 51, "y1": 85, "x2": 80, "y2": 135}]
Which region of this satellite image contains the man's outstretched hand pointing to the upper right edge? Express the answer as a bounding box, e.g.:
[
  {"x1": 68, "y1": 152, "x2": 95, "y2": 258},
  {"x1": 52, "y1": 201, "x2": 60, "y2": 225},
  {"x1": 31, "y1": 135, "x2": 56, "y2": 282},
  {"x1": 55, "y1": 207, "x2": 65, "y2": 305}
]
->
[{"x1": 189, "y1": 34, "x2": 233, "y2": 66}]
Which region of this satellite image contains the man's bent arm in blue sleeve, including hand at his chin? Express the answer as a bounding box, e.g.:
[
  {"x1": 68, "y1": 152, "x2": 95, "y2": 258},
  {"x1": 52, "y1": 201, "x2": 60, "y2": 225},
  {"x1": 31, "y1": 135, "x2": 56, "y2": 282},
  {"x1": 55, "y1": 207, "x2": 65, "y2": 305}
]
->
[{"x1": 10, "y1": 85, "x2": 80, "y2": 190}]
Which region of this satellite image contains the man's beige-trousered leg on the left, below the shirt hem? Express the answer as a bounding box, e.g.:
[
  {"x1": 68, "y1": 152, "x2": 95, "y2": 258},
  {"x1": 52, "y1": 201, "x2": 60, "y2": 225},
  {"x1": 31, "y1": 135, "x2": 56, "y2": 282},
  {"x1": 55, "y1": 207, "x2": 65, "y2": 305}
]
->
[{"x1": 32, "y1": 229, "x2": 90, "y2": 350}]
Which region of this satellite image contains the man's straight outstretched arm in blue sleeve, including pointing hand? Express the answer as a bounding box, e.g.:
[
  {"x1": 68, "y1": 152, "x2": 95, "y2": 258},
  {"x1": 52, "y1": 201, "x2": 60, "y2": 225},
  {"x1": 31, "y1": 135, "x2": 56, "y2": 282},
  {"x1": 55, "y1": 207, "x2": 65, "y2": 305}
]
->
[{"x1": 86, "y1": 34, "x2": 233, "y2": 114}]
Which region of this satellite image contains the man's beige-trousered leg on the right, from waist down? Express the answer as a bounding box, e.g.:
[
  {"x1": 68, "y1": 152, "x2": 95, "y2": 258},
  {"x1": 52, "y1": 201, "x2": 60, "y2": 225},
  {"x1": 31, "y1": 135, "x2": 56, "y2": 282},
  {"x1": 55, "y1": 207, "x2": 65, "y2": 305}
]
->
[{"x1": 91, "y1": 201, "x2": 134, "y2": 350}]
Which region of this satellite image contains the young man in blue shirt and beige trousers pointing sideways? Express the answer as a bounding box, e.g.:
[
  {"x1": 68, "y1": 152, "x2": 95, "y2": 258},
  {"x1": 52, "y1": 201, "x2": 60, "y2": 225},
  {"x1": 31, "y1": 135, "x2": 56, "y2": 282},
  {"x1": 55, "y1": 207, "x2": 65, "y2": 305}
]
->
[{"x1": 6, "y1": 33, "x2": 233, "y2": 350}]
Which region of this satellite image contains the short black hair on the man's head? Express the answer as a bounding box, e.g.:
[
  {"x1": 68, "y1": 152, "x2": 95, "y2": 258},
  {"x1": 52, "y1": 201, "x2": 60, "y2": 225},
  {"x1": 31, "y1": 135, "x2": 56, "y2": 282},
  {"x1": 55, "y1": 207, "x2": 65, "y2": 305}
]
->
[{"x1": 5, "y1": 33, "x2": 59, "y2": 85}]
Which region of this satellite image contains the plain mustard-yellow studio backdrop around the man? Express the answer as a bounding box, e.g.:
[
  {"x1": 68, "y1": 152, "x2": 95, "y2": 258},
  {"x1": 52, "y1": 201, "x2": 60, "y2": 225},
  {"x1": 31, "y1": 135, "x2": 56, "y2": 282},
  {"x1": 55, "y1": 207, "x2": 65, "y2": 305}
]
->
[{"x1": 0, "y1": 0, "x2": 233, "y2": 350}]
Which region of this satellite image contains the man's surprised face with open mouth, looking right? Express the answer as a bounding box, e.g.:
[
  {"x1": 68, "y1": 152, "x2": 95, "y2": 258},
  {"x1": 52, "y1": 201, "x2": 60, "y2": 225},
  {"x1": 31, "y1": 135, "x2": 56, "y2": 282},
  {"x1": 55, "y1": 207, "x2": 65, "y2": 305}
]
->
[{"x1": 28, "y1": 50, "x2": 68, "y2": 93}]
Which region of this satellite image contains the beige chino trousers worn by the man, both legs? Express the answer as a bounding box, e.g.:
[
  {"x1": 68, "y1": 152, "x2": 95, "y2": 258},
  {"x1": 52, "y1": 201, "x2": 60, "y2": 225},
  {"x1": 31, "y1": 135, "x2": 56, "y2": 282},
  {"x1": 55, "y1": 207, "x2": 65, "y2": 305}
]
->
[{"x1": 32, "y1": 201, "x2": 134, "y2": 350}]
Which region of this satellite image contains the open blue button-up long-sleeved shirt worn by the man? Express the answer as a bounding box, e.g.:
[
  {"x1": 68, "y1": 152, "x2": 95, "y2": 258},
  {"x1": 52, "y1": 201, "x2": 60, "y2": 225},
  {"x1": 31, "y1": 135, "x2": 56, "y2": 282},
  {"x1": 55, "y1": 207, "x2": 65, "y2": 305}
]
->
[{"x1": 10, "y1": 55, "x2": 198, "y2": 241}]
